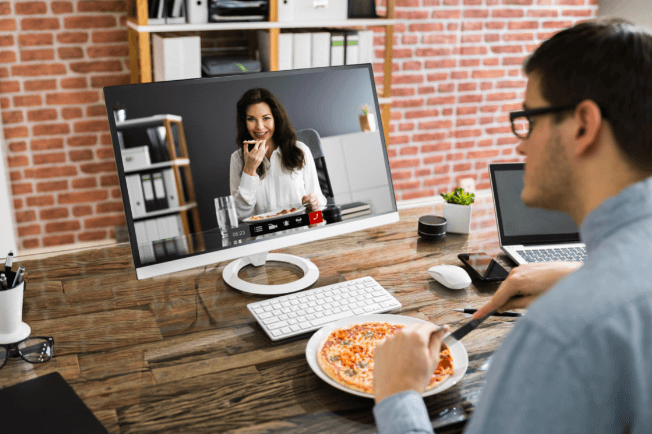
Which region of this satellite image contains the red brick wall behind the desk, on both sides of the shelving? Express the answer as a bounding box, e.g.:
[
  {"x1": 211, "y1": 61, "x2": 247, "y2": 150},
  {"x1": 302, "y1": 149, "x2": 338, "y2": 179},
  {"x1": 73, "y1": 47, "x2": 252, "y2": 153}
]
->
[{"x1": 0, "y1": 0, "x2": 597, "y2": 248}]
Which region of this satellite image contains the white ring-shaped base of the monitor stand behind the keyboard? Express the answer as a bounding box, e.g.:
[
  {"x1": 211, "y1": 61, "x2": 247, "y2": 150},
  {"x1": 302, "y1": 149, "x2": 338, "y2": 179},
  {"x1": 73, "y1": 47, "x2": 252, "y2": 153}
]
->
[{"x1": 222, "y1": 252, "x2": 319, "y2": 295}]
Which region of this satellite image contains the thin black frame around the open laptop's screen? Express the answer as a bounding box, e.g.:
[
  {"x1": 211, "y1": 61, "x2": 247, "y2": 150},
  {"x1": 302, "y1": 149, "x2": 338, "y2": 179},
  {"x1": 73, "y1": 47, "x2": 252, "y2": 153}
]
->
[{"x1": 489, "y1": 163, "x2": 580, "y2": 246}]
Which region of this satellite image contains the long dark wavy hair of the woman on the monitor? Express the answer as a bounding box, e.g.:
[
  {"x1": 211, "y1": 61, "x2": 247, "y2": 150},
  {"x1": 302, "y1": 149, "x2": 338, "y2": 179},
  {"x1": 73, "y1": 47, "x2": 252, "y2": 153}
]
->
[{"x1": 236, "y1": 88, "x2": 305, "y2": 179}]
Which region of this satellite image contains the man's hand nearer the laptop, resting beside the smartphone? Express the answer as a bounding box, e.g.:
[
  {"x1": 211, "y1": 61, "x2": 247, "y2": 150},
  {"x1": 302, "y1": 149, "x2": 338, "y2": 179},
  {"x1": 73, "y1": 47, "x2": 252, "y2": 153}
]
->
[{"x1": 473, "y1": 262, "x2": 582, "y2": 319}]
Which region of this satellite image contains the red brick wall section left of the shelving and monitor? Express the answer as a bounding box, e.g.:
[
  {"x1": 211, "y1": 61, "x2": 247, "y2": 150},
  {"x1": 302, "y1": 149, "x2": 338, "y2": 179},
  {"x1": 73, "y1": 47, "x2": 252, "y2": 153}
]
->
[{"x1": 0, "y1": 1, "x2": 129, "y2": 248}]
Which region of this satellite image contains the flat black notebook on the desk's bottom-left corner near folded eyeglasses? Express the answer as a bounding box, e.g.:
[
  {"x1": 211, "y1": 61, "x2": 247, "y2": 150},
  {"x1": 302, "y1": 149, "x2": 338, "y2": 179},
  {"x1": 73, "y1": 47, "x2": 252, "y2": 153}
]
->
[{"x1": 0, "y1": 372, "x2": 108, "y2": 434}]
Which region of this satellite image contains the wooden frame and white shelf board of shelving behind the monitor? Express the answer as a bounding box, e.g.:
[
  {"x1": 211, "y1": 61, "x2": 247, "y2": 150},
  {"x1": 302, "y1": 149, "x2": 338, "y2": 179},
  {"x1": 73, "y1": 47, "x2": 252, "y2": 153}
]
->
[{"x1": 127, "y1": 0, "x2": 395, "y2": 143}]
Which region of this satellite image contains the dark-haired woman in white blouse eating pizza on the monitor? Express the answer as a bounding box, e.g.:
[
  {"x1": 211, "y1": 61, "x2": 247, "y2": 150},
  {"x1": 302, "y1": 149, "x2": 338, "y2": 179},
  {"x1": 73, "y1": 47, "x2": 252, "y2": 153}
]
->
[{"x1": 230, "y1": 89, "x2": 326, "y2": 220}]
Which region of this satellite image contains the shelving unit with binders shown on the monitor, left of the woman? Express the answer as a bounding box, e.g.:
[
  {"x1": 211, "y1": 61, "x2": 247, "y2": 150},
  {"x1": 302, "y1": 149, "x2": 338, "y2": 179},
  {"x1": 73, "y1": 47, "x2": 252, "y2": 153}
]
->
[{"x1": 116, "y1": 114, "x2": 204, "y2": 263}]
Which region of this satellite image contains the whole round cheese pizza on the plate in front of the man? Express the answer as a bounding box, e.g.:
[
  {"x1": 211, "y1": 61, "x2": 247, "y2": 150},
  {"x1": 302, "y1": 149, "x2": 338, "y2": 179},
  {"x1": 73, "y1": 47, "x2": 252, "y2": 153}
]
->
[{"x1": 317, "y1": 322, "x2": 453, "y2": 395}]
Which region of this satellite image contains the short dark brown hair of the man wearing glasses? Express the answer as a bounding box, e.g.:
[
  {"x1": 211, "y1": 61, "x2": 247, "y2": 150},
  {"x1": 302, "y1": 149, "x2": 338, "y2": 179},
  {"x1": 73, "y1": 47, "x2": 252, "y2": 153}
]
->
[{"x1": 524, "y1": 18, "x2": 652, "y2": 172}]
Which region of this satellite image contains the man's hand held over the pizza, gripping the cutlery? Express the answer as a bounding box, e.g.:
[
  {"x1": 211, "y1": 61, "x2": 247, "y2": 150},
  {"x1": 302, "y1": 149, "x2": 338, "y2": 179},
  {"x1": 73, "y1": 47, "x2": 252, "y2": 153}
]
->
[{"x1": 374, "y1": 324, "x2": 449, "y2": 404}]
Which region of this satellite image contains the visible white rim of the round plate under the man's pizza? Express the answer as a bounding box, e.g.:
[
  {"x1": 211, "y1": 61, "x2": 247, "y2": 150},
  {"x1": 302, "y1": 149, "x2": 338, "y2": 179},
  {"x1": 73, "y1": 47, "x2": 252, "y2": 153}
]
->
[{"x1": 306, "y1": 314, "x2": 469, "y2": 398}]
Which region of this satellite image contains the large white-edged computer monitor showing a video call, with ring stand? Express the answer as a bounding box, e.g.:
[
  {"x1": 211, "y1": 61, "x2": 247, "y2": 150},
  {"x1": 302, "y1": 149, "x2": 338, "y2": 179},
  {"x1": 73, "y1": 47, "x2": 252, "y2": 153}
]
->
[{"x1": 104, "y1": 64, "x2": 398, "y2": 295}]
